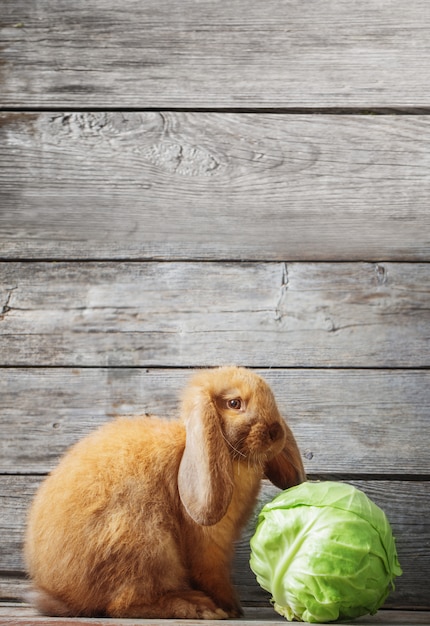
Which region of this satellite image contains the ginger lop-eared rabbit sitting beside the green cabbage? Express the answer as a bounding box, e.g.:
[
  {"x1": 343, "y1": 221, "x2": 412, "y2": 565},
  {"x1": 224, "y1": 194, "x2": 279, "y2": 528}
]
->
[{"x1": 24, "y1": 366, "x2": 306, "y2": 619}]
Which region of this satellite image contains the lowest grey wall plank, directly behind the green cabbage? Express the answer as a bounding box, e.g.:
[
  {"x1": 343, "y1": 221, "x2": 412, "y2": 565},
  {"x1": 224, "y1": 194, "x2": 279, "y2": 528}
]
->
[{"x1": 0, "y1": 476, "x2": 430, "y2": 608}]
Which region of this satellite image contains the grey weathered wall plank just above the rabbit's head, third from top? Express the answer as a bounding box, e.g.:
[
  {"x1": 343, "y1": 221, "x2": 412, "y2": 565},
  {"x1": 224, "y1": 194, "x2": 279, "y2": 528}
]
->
[{"x1": 0, "y1": 263, "x2": 430, "y2": 367}]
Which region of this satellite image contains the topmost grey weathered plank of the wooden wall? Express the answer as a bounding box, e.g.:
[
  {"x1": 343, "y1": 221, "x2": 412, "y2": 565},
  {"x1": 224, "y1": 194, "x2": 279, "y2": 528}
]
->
[{"x1": 0, "y1": 0, "x2": 430, "y2": 108}]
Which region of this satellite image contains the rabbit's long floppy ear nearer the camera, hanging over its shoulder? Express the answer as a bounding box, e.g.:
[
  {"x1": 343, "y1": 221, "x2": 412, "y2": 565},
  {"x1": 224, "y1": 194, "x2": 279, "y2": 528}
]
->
[{"x1": 178, "y1": 390, "x2": 233, "y2": 526}]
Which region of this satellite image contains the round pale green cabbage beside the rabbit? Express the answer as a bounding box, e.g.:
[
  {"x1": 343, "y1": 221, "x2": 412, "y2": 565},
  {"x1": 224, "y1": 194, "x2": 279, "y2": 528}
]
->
[{"x1": 250, "y1": 481, "x2": 402, "y2": 622}]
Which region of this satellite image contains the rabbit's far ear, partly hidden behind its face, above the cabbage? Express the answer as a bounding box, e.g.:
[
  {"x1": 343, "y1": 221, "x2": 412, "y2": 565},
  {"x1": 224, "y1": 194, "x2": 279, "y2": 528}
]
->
[{"x1": 264, "y1": 425, "x2": 306, "y2": 489}]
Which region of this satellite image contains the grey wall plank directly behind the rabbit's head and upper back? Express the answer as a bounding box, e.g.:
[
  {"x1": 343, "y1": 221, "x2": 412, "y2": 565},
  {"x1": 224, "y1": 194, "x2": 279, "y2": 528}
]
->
[{"x1": 0, "y1": 368, "x2": 430, "y2": 477}]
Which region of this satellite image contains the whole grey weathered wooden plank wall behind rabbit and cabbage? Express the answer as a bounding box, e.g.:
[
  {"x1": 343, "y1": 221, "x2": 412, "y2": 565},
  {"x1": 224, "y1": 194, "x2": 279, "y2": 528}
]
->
[{"x1": 0, "y1": 0, "x2": 430, "y2": 609}]
